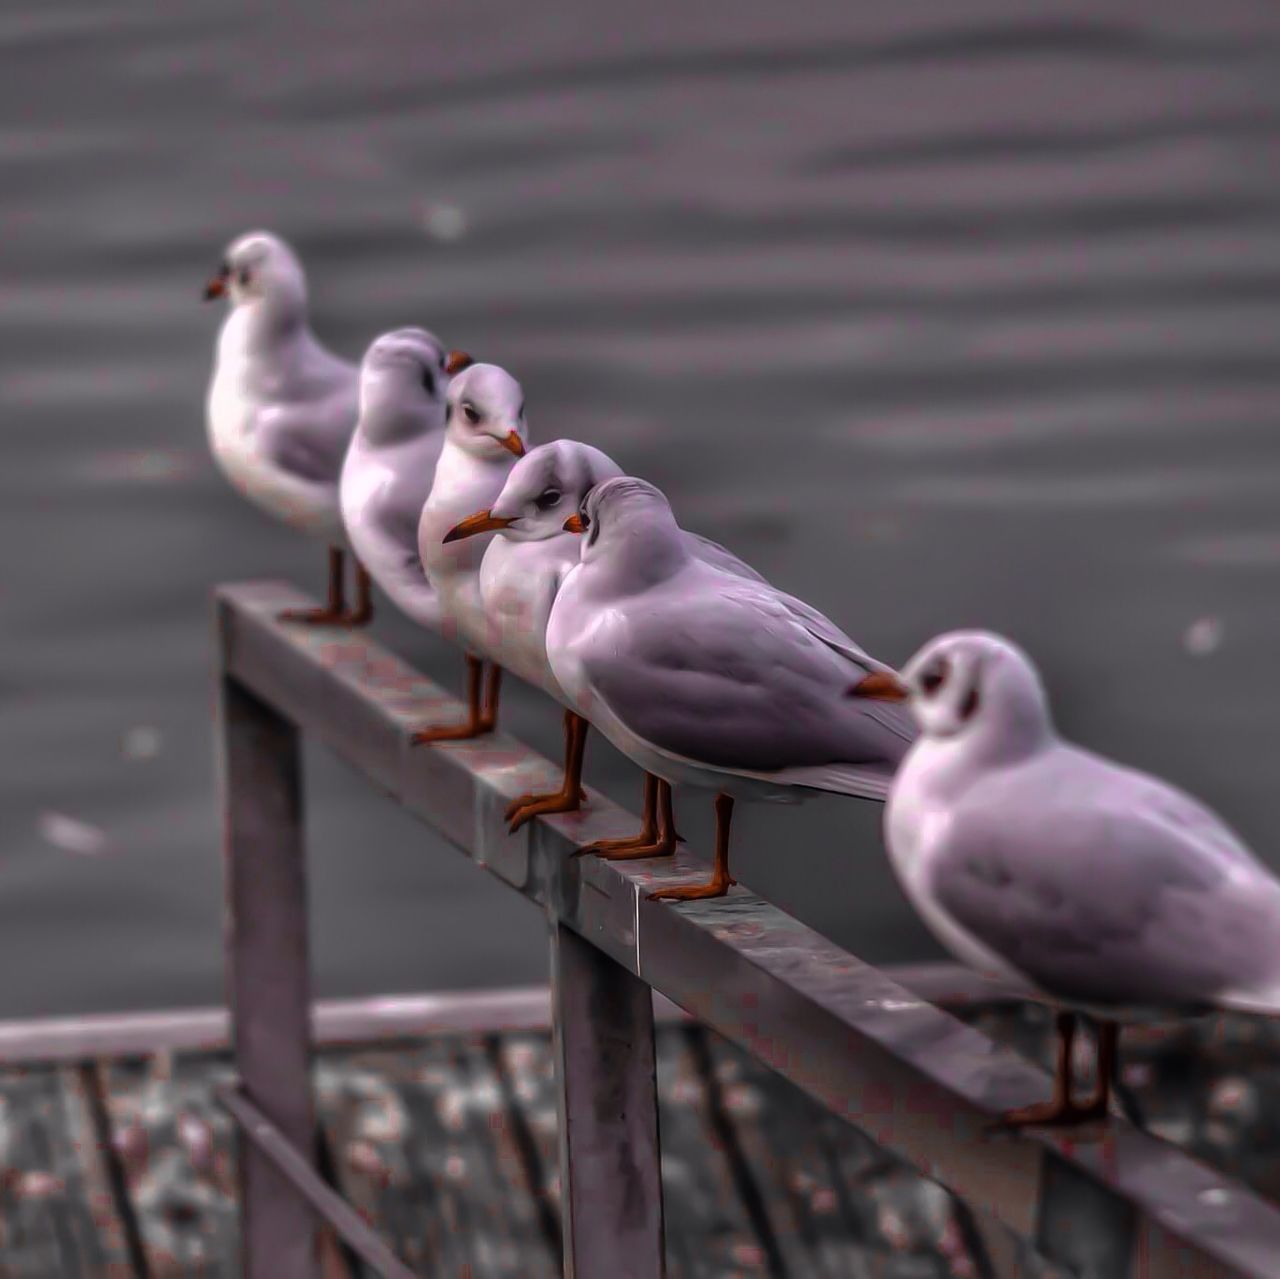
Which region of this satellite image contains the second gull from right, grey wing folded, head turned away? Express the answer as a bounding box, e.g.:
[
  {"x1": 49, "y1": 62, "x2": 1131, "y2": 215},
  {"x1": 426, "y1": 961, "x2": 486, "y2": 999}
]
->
[{"x1": 547, "y1": 476, "x2": 913, "y2": 901}]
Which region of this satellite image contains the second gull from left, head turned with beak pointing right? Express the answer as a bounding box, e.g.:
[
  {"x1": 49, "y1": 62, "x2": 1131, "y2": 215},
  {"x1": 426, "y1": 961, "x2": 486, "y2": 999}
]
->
[{"x1": 339, "y1": 328, "x2": 471, "y2": 630}]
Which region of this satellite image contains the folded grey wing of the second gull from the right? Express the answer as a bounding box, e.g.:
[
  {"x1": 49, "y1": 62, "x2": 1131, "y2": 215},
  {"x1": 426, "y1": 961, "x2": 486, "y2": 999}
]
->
[{"x1": 582, "y1": 574, "x2": 909, "y2": 772}]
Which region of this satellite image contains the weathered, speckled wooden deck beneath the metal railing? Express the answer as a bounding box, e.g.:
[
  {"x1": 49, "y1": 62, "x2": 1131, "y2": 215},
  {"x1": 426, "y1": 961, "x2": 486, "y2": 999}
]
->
[{"x1": 0, "y1": 1008, "x2": 1280, "y2": 1279}]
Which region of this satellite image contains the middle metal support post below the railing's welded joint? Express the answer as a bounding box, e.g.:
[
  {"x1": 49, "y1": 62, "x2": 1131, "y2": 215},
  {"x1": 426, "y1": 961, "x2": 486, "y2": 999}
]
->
[{"x1": 552, "y1": 923, "x2": 664, "y2": 1279}]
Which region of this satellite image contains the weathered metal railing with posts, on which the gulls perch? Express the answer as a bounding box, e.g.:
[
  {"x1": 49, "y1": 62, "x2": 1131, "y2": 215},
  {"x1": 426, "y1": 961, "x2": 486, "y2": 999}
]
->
[{"x1": 216, "y1": 584, "x2": 1280, "y2": 1279}]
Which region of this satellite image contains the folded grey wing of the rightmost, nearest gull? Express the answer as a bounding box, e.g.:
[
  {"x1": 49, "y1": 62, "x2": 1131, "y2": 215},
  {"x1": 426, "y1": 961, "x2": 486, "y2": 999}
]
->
[{"x1": 933, "y1": 752, "x2": 1275, "y2": 1006}]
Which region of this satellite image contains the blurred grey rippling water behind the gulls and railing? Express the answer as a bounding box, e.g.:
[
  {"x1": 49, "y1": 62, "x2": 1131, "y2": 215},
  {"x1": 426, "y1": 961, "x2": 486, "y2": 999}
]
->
[{"x1": 0, "y1": 0, "x2": 1280, "y2": 1015}]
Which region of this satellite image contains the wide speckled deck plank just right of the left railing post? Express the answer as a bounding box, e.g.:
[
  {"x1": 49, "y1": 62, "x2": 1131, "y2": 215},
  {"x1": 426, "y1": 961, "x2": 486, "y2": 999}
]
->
[{"x1": 316, "y1": 1038, "x2": 559, "y2": 1279}]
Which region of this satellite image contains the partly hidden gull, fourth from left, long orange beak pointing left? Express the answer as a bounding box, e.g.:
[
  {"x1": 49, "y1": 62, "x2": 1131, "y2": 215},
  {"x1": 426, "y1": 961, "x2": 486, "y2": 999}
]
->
[{"x1": 444, "y1": 439, "x2": 763, "y2": 839}]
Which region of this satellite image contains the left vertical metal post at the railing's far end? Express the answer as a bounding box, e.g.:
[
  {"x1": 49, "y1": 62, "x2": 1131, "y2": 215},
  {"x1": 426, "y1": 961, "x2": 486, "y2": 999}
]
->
[{"x1": 218, "y1": 675, "x2": 319, "y2": 1279}]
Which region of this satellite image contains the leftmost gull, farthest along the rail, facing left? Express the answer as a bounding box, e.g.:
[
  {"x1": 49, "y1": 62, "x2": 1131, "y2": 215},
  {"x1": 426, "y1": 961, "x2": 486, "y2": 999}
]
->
[{"x1": 205, "y1": 230, "x2": 369, "y2": 625}]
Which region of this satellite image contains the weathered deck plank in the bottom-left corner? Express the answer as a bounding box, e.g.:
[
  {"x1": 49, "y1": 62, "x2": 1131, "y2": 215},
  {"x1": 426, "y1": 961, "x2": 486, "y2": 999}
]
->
[{"x1": 0, "y1": 1066, "x2": 133, "y2": 1279}]
